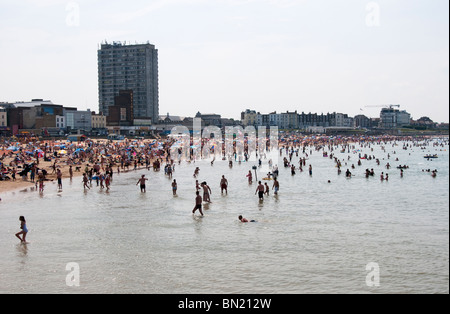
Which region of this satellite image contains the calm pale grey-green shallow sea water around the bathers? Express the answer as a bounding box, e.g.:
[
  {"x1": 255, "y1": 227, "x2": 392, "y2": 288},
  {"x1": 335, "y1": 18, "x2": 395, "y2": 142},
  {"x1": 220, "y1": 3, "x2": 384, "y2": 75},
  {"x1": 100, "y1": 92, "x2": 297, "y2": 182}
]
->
[{"x1": 0, "y1": 139, "x2": 449, "y2": 293}]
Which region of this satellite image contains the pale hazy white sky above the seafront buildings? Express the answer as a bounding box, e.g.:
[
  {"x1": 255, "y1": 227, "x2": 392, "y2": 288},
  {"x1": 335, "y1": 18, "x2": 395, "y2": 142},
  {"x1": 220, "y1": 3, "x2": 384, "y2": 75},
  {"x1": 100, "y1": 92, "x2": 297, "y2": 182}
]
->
[{"x1": 0, "y1": 0, "x2": 449, "y2": 122}]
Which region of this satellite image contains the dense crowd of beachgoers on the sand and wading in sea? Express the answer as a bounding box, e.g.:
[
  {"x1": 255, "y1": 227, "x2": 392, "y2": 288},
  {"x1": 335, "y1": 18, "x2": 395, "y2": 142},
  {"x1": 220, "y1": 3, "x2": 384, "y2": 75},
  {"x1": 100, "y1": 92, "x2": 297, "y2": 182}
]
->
[{"x1": 0, "y1": 134, "x2": 448, "y2": 240}]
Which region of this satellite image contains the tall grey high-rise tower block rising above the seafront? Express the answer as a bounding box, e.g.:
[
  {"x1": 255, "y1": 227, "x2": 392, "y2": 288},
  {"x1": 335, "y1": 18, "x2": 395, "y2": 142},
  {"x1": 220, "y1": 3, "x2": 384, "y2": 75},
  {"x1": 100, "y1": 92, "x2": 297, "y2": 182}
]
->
[{"x1": 98, "y1": 43, "x2": 159, "y2": 121}]
